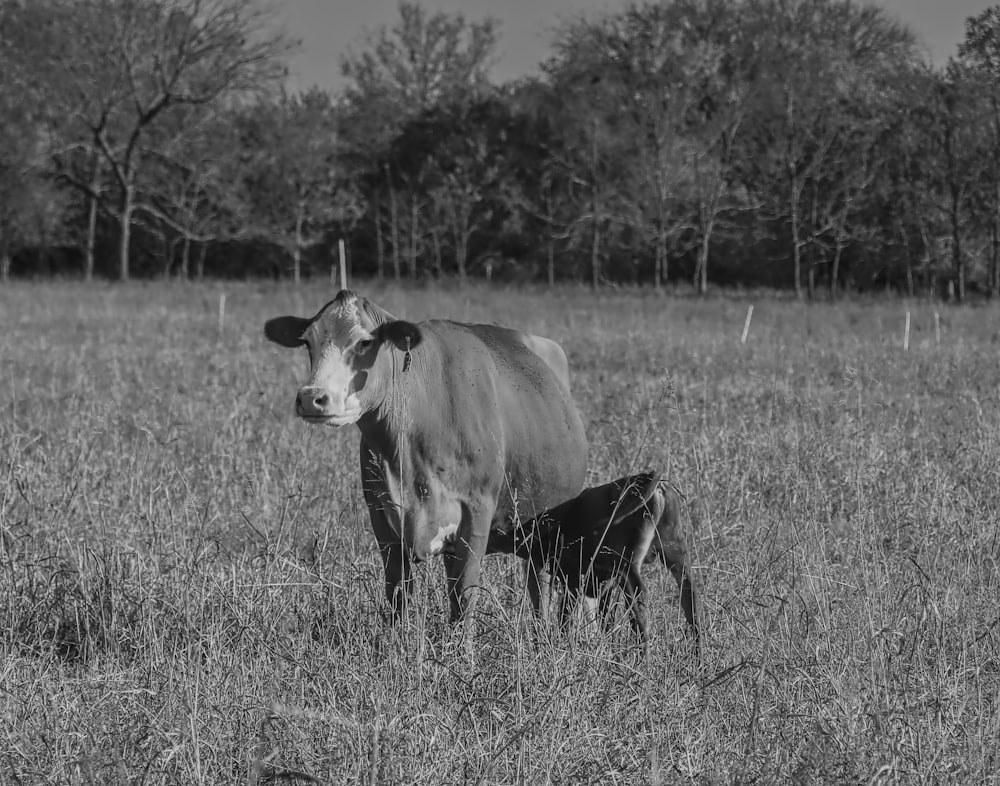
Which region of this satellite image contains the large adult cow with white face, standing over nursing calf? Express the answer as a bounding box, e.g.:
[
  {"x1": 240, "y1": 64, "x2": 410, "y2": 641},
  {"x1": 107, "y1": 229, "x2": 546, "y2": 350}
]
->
[{"x1": 264, "y1": 290, "x2": 587, "y2": 622}]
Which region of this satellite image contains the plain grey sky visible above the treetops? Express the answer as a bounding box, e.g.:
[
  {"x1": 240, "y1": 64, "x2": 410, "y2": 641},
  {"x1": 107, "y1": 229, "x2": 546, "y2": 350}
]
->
[{"x1": 276, "y1": 0, "x2": 998, "y2": 89}]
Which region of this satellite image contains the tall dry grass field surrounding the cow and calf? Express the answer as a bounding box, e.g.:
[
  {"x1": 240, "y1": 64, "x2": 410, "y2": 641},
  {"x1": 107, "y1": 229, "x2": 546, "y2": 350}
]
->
[{"x1": 0, "y1": 282, "x2": 1000, "y2": 784}]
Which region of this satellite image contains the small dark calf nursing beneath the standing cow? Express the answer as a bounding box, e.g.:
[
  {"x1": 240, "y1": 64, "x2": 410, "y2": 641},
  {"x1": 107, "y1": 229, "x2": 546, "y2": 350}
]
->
[{"x1": 514, "y1": 472, "x2": 699, "y2": 646}]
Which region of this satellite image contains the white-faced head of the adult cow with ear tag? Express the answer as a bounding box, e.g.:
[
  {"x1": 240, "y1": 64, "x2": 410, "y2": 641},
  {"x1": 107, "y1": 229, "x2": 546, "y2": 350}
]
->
[{"x1": 264, "y1": 289, "x2": 421, "y2": 426}]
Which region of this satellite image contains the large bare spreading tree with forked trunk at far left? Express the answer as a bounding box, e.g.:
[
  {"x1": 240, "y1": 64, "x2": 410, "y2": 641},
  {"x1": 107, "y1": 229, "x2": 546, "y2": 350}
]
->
[{"x1": 18, "y1": 0, "x2": 289, "y2": 279}]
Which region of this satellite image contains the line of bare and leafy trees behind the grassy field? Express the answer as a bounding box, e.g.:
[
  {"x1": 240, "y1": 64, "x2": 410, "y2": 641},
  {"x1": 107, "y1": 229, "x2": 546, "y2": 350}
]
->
[{"x1": 0, "y1": 0, "x2": 1000, "y2": 300}]
